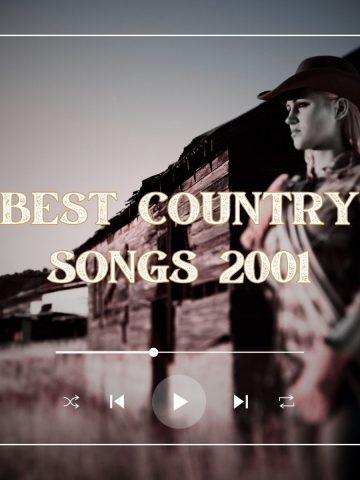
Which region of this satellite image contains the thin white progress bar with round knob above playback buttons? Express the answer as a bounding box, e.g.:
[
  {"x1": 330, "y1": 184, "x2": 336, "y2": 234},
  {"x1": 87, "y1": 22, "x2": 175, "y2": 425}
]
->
[{"x1": 55, "y1": 347, "x2": 305, "y2": 357}]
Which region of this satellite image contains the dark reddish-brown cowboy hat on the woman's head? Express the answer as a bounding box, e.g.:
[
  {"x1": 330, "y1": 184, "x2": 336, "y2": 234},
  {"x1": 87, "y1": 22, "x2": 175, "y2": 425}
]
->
[{"x1": 258, "y1": 55, "x2": 360, "y2": 108}]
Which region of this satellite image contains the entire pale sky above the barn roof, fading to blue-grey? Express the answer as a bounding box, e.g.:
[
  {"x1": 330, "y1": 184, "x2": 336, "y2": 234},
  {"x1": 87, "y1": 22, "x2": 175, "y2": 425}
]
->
[{"x1": 0, "y1": 0, "x2": 360, "y2": 274}]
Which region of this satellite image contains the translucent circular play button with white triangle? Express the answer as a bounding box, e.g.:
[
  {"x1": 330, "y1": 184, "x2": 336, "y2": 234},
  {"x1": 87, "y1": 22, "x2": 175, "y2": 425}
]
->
[{"x1": 152, "y1": 375, "x2": 206, "y2": 428}]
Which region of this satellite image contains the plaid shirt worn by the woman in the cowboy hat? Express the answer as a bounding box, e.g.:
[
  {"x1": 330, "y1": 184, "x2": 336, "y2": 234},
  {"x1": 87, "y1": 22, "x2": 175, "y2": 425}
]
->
[{"x1": 264, "y1": 152, "x2": 360, "y2": 384}]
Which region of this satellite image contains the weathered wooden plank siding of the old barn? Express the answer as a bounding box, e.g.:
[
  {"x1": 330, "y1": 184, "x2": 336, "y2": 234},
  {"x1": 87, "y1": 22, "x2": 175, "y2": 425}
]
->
[{"x1": 89, "y1": 152, "x2": 229, "y2": 350}]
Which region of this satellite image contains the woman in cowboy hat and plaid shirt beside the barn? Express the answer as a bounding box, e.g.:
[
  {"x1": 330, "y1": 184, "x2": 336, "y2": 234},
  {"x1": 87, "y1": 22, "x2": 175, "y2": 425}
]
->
[{"x1": 240, "y1": 56, "x2": 360, "y2": 479}]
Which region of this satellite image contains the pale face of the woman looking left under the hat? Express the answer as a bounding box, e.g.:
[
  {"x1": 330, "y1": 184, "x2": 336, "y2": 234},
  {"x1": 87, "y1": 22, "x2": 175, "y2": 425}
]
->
[{"x1": 285, "y1": 90, "x2": 339, "y2": 150}]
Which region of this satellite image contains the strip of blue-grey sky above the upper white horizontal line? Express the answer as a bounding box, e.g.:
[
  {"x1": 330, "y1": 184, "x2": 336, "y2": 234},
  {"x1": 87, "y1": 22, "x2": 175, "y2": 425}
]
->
[{"x1": 0, "y1": 0, "x2": 360, "y2": 34}]
